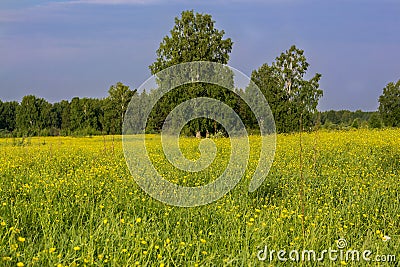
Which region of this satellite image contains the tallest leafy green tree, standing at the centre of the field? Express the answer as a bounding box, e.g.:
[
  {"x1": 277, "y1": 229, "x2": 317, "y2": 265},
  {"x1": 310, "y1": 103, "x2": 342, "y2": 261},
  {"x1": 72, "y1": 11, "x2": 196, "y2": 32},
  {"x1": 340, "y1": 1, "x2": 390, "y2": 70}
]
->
[{"x1": 149, "y1": 10, "x2": 233, "y2": 136}]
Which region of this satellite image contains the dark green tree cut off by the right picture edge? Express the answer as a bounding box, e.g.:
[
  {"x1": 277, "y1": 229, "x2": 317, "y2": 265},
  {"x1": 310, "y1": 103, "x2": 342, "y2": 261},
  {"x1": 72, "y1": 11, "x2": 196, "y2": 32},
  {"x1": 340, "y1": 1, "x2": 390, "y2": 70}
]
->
[{"x1": 379, "y1": 80, "x2": 400, "y2": 127}]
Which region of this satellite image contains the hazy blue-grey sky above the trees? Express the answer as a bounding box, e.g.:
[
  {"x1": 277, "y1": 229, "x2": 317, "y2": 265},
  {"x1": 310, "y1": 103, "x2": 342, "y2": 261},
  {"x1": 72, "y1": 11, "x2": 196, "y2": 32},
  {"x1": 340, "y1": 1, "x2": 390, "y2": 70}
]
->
[{"x1": 0, "y1": 0, "x2": 400, "y2": 111}]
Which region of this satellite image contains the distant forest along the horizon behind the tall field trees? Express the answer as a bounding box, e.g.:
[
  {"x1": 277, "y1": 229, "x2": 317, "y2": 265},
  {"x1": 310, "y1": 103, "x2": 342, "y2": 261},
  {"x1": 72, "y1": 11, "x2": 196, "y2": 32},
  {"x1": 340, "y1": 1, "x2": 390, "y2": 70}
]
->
[{"x1": 0, "y1": 88, "x2": 383, "y2": 137}]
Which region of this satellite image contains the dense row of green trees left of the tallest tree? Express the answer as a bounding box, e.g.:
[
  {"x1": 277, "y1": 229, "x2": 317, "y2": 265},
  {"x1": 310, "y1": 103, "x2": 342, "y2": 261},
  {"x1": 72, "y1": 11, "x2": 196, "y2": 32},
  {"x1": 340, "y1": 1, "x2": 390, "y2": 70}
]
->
[{"x1": 0, "y1": 82, "x2": 136, "y2": 136}]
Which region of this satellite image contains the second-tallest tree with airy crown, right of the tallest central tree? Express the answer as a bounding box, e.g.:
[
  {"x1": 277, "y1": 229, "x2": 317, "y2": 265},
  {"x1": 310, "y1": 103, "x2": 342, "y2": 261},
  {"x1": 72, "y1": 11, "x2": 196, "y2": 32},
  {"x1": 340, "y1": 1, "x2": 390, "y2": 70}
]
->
[{"x1": 251, "y1": 45, "x2": 323, "y2": 135}]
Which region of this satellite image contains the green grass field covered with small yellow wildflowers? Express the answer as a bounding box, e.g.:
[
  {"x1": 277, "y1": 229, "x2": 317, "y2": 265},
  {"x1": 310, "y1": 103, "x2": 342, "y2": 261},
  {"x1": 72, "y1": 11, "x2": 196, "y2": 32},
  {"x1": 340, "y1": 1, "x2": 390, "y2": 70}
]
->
[{"x1": 0, "y1": 130, "x2": 400, "y2": 266}]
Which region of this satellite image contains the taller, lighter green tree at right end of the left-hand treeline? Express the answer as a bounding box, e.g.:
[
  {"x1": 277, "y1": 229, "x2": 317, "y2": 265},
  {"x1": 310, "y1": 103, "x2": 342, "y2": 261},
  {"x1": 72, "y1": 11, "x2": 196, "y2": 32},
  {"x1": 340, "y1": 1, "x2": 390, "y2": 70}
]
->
[{"x1": 103, "y1": 82, "x2": 136, "y2": 134}]
